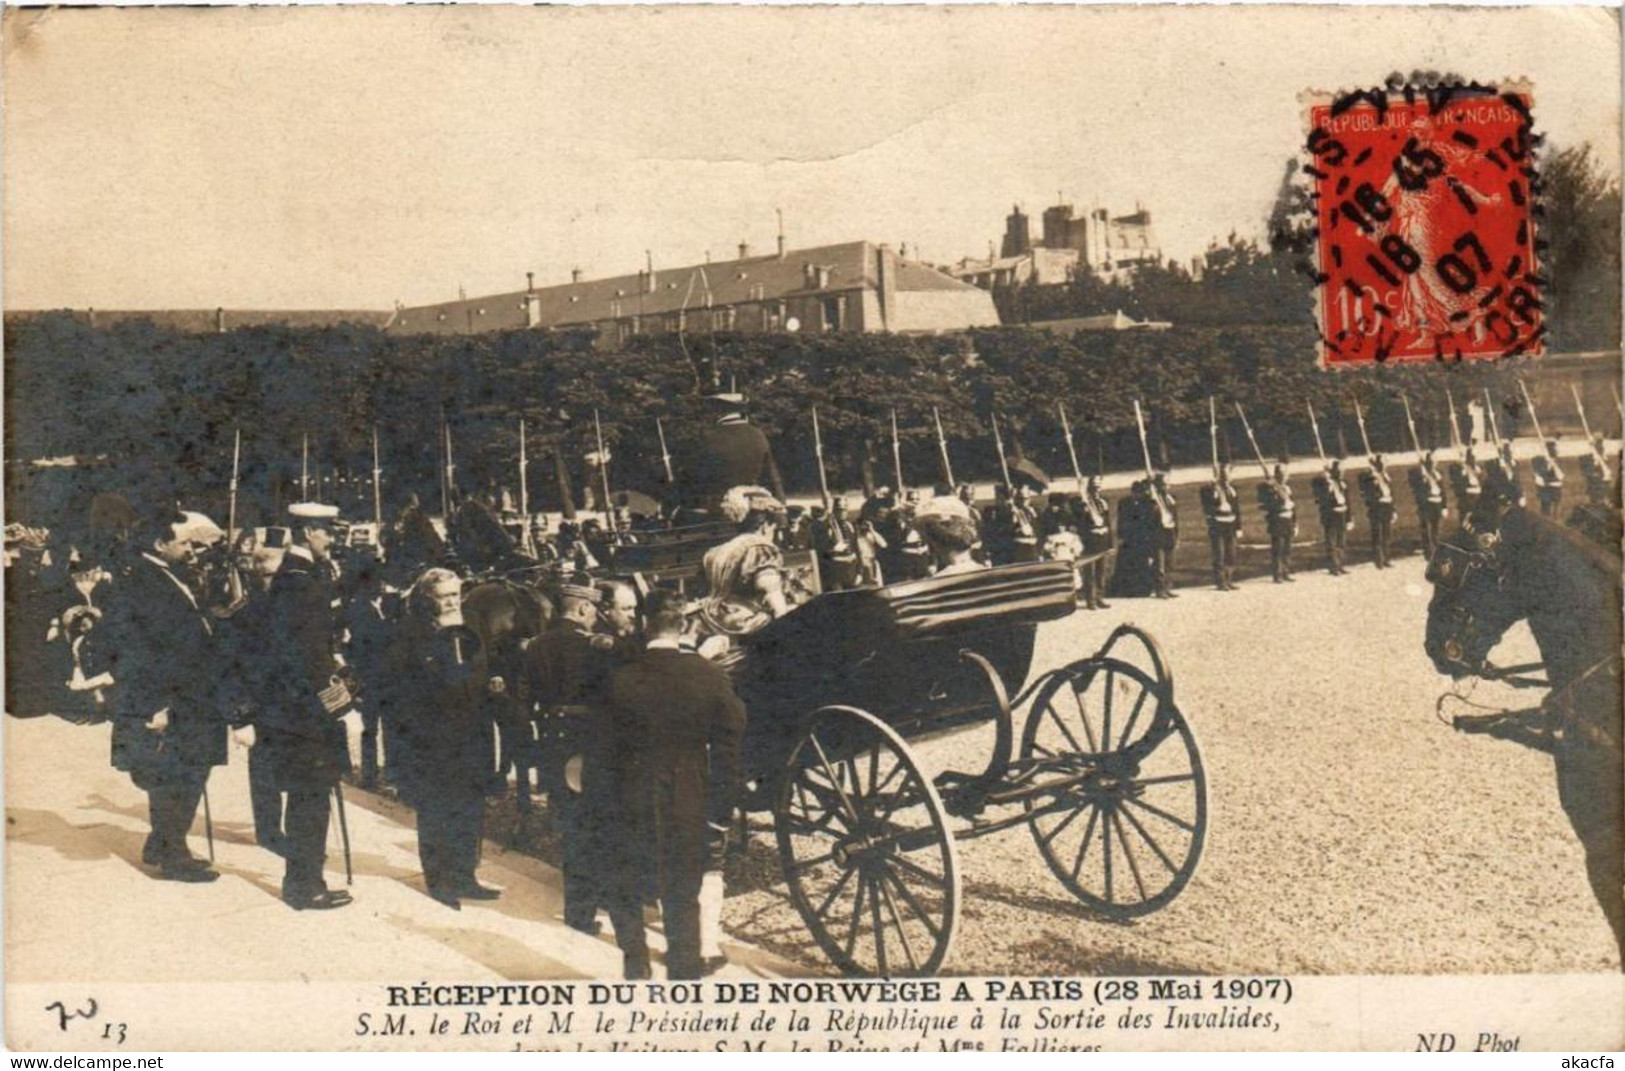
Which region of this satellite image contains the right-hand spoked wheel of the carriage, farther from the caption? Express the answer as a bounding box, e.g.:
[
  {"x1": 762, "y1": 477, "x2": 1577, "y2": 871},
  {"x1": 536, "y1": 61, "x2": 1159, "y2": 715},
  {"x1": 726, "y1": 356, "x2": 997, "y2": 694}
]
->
[{"x1": 1021, "y1": 658, "x2": 1207, "y2": 920}]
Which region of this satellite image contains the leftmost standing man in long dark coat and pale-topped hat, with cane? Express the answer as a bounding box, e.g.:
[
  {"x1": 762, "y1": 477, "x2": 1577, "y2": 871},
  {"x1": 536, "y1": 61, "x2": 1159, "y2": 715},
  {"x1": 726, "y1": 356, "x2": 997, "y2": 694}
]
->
[{"x1": 104, "y1": 514, "x2": 228, "y2": 882}]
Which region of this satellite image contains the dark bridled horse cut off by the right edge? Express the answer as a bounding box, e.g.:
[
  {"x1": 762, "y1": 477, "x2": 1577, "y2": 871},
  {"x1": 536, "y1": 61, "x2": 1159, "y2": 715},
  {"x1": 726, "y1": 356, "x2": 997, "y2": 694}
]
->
[{"x1": 1425, "y1": 484, "x2": 1625, "y2": 960}]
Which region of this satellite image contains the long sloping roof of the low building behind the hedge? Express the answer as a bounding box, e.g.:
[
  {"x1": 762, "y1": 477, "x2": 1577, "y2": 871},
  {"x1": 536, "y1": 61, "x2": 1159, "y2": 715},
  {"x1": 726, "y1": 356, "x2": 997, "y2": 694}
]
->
[{"x1": 388, "y1": 242, "x2": 975, "y2": 333}]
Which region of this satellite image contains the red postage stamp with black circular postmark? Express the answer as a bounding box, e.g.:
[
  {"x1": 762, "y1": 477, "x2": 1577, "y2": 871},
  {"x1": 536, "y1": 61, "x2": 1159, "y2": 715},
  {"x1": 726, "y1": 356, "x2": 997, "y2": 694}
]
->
[{"x1": 1305, "y1": 85, "x2": 1545, "y2": 367}]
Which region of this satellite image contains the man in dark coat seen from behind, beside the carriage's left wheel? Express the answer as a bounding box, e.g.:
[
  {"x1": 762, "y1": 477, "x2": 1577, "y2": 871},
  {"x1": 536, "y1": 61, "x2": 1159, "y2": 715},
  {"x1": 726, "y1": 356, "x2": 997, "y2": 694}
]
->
[{"x1": 609, "y1": 592, "x2": 744, "y2": 978}]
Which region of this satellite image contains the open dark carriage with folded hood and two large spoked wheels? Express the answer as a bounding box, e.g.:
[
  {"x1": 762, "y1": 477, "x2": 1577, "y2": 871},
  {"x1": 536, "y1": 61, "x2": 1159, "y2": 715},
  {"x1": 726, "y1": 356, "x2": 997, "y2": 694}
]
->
[{"x1": 598, "y1": 526, "x2": 1207, "y2": 975}]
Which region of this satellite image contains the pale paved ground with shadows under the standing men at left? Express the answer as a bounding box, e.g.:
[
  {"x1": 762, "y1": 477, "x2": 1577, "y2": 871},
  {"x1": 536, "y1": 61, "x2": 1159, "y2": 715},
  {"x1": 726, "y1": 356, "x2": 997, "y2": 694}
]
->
[{"x1": 5, "y1": 717, "x2": 785, "y2": 983}]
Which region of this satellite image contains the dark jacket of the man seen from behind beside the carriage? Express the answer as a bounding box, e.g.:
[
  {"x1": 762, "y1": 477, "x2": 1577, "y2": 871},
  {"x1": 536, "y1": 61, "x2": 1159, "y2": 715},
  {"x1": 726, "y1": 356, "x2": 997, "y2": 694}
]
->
[{"x1": 609, "y1": 650, "x2": 744, "y2": 891}]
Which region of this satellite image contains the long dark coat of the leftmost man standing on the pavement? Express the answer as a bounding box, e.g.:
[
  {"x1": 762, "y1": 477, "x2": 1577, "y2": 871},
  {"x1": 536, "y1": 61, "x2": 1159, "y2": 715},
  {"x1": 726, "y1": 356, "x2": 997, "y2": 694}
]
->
[{"x1": 101, "y1": 557, "x2": 228, "y2": 787}]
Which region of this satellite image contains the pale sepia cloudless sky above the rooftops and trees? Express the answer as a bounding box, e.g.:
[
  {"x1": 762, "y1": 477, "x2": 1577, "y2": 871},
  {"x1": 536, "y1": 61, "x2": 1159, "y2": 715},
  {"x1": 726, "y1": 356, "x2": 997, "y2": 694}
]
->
[{"x1": 3, "y1": 7, "x2": 1620, "y2": 309}]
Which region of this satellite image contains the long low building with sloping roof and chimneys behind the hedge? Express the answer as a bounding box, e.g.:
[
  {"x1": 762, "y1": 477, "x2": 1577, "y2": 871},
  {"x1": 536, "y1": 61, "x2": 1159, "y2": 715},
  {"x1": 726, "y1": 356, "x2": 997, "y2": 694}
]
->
[{"x1": 387, "y1": 239, "x2": 999, "y2": 348}]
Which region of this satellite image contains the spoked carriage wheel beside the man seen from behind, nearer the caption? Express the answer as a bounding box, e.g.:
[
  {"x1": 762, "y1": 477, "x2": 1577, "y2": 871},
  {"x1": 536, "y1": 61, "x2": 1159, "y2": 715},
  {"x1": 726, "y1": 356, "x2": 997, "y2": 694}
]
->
[{"x1": 774, "y1": 707, "x2": 959, "y2": 977}]
